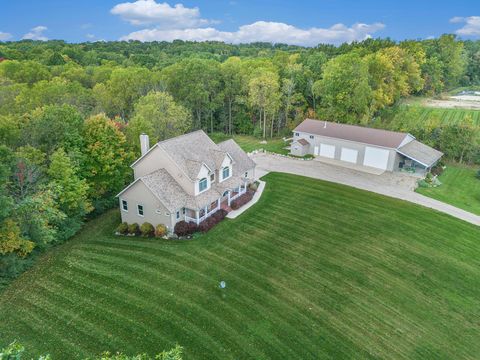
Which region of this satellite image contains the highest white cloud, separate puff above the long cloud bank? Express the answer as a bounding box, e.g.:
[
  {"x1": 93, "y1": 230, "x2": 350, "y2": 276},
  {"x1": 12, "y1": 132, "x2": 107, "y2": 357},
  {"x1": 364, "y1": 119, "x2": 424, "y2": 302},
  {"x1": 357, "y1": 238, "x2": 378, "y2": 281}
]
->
[{"x1": 110, "y1": 0, "x2": 212, "y2": 30}]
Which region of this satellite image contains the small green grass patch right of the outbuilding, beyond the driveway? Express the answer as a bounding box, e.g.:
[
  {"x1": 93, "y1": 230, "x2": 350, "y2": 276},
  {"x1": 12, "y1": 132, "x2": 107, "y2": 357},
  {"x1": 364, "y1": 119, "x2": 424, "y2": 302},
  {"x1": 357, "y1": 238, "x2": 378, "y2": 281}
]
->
[{"x1": 417, "y1": 165, "x2": 480, "y2": 215}]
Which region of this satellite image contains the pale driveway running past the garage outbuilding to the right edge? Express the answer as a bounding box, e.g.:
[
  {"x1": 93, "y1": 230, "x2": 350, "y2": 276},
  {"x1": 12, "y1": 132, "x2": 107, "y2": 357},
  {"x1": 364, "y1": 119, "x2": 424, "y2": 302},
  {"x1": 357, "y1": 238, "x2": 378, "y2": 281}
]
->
[{"x1": 252, "y1": 153, "x2": 480, "y2": 226}]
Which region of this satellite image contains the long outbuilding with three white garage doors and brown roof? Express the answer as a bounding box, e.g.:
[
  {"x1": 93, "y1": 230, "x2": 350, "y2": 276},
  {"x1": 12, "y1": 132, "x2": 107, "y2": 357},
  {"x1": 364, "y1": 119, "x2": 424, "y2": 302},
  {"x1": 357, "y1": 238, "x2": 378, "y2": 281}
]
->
[{"x1": 290, "y1": 119, "x2": 443, "y2": 173}]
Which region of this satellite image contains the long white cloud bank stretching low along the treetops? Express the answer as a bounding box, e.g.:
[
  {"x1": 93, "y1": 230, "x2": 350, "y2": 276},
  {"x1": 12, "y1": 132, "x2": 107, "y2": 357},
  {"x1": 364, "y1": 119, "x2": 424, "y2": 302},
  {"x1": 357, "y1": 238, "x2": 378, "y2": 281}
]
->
[{"x1": 121, "y1": 21, "x2": 385, "y2": 46}]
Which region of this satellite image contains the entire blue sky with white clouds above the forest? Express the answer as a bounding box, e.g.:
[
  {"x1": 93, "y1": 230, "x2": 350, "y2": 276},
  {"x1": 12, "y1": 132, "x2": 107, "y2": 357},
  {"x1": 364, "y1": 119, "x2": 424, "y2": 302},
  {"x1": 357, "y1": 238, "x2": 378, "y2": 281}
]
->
[{"x1": 0, "y1": 0, "x2": 480, "y2": 46}]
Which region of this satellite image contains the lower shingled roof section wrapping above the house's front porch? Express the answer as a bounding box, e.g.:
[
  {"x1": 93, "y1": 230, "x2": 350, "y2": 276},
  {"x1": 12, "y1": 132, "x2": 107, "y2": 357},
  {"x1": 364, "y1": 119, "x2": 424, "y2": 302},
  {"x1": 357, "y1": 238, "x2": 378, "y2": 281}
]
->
[{"x1": 140, "y1": 169, "x2": 244, "y2": 212}]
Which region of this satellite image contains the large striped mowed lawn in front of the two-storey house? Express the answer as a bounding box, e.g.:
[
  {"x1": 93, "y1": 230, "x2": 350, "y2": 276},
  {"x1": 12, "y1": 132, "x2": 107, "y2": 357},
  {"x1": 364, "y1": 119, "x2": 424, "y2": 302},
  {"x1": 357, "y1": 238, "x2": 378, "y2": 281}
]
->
[{"x1": 0, "y1": 173, "x2": 480, "y2": 360}]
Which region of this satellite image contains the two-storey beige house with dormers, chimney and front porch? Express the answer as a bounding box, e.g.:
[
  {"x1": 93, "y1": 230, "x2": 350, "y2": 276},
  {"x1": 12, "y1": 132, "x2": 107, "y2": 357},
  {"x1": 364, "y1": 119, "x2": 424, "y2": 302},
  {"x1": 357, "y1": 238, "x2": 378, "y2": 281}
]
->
[{"x1": 117, "y1": 130, "x2": 255, "y2": 232}]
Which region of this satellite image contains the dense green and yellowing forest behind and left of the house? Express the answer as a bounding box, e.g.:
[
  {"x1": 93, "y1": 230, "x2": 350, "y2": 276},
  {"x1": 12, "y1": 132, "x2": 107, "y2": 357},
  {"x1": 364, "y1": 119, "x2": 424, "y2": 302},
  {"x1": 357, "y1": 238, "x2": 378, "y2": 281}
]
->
[{"x1": 0, "y1": 35, "x2": 480, "y2": 281}]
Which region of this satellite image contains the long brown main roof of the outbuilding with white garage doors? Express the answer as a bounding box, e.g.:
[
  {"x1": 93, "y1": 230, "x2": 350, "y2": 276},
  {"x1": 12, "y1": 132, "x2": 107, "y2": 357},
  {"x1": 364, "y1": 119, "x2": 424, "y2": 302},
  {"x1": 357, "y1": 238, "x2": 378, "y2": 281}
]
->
[{"x1": 293, "y1": 119, "x2": 408, "y2": 149}]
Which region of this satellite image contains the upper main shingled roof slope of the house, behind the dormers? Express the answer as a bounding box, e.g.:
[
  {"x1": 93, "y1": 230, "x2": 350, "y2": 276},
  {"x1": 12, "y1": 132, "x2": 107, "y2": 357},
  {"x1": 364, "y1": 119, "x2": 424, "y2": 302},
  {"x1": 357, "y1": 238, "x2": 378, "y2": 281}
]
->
[{"x1": 157, "y1": 130, "x2": 226, "y2": 180}]
